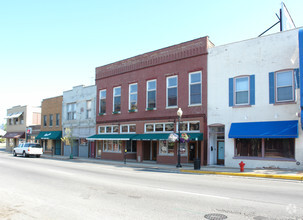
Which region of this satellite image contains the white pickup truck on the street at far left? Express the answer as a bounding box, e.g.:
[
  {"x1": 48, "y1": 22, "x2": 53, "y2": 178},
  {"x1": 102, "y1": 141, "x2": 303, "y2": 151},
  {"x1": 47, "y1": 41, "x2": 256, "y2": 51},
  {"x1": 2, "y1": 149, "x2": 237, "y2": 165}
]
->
[{"x1": 13, "y1": 143, "x2": 43, "y2": 157}]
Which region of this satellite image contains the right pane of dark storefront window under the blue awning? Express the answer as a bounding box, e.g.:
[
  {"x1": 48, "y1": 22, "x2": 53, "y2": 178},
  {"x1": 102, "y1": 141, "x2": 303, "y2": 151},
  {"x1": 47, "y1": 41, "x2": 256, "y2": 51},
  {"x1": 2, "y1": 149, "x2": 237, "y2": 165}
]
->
[{"x1": 265, "y1": 138, "x2": 295, "y2": 158}]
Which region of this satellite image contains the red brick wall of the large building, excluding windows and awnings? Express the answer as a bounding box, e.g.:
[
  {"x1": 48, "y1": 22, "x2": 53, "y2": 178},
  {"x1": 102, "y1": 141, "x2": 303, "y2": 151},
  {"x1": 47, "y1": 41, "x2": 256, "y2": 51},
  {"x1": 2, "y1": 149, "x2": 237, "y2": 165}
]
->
[{"x1": 96, "y1": 37, "x2": 211, "y2": 164}]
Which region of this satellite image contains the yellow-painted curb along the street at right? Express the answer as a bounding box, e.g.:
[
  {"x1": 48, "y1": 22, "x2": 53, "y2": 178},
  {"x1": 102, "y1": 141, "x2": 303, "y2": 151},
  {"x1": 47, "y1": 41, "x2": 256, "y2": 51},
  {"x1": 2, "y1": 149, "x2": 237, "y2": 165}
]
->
[{"x1": 180, "y1": 170, "x2": 303, "y2": 181}]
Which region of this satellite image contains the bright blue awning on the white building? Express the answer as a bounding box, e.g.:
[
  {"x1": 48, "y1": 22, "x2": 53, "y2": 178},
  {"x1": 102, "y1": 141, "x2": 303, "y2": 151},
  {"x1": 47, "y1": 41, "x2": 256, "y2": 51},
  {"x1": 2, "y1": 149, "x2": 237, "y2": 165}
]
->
[{"x1": 228, "y1": 121, "x2": 298, "y2": 138}]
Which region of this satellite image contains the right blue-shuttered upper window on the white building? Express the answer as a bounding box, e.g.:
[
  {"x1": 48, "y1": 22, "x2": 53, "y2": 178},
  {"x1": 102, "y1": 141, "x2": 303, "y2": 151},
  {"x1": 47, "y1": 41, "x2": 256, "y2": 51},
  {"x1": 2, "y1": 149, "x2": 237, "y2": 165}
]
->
[{"x1": 269, "y1": 69, "x2": 299, "y2": 104}]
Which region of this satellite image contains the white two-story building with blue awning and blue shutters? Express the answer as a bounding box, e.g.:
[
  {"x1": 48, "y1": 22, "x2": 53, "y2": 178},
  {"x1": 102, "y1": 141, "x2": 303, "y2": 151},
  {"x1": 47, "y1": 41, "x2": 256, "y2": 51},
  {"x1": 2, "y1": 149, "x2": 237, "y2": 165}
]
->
[{"x1": 208, "y1": 29, "x2": 303, "y2": 169}]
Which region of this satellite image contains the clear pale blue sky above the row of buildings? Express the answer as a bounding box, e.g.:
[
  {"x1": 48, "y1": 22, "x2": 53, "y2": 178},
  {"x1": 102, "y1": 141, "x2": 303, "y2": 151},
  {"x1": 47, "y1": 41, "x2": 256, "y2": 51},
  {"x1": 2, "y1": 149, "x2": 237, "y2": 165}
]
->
[{"x1": 0, "y1": 0, "x2": 303, "y2": 125}]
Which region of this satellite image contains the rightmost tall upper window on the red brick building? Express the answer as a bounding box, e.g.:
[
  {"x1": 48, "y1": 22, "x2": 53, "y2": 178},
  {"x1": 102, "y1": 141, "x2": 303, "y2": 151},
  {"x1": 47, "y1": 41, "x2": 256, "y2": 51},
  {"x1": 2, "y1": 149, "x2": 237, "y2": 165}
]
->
[{"x1": 189, "y1": 72, "x2": 202, "y2": 105}]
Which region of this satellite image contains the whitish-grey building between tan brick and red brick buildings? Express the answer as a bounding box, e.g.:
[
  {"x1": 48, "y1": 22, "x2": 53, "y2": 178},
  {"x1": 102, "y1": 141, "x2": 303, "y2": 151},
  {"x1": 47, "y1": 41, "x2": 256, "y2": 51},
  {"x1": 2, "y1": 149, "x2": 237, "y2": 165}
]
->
[{"x1": 62, "y1": 85, "x2": 96, "y2": 157}]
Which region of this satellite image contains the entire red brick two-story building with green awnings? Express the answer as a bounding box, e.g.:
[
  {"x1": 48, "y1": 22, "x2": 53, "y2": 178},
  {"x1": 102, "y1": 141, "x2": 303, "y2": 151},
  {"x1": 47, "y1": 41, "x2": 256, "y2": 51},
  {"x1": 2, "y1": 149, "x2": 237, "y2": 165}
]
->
[{"x1": 88, "y1": 37, "x2": 213, "y2": 164}]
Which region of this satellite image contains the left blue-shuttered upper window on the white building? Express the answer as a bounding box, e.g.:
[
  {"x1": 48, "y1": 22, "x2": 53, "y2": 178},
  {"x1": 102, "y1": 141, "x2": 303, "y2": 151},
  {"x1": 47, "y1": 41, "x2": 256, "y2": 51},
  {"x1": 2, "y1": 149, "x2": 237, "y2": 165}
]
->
[{"x1": 229, "y1": 75, "x2": 255, "y2": 106}]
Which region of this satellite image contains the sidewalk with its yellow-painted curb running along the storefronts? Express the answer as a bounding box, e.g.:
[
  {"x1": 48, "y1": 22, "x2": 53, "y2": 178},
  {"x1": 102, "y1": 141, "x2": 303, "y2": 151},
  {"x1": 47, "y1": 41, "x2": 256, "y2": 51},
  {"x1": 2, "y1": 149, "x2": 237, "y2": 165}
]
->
[{"x1": 41, "y1": 154, "x2": 303, "y2": 181}]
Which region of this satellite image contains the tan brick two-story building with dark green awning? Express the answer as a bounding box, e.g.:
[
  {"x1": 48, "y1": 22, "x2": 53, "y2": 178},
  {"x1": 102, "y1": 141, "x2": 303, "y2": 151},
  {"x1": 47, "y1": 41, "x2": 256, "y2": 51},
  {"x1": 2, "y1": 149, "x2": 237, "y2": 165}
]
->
[{"x1": 36, "y1": 96, "x2": 63, "y2": 155}]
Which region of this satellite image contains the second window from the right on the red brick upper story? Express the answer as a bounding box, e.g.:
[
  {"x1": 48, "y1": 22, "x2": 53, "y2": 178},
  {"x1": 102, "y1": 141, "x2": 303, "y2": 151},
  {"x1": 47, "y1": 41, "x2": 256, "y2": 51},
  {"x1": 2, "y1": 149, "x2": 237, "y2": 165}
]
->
[{"x1": 166, "y1": 76, "x2": 178, "y2": 107}]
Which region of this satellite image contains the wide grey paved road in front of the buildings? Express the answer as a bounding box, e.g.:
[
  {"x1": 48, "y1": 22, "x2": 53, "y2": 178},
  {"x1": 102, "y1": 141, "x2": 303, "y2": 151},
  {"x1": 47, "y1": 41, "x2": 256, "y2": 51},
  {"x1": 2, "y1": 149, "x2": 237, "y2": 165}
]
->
[{"x1": 0, "y1": 151, "x2": 303, "y2": 220}]
